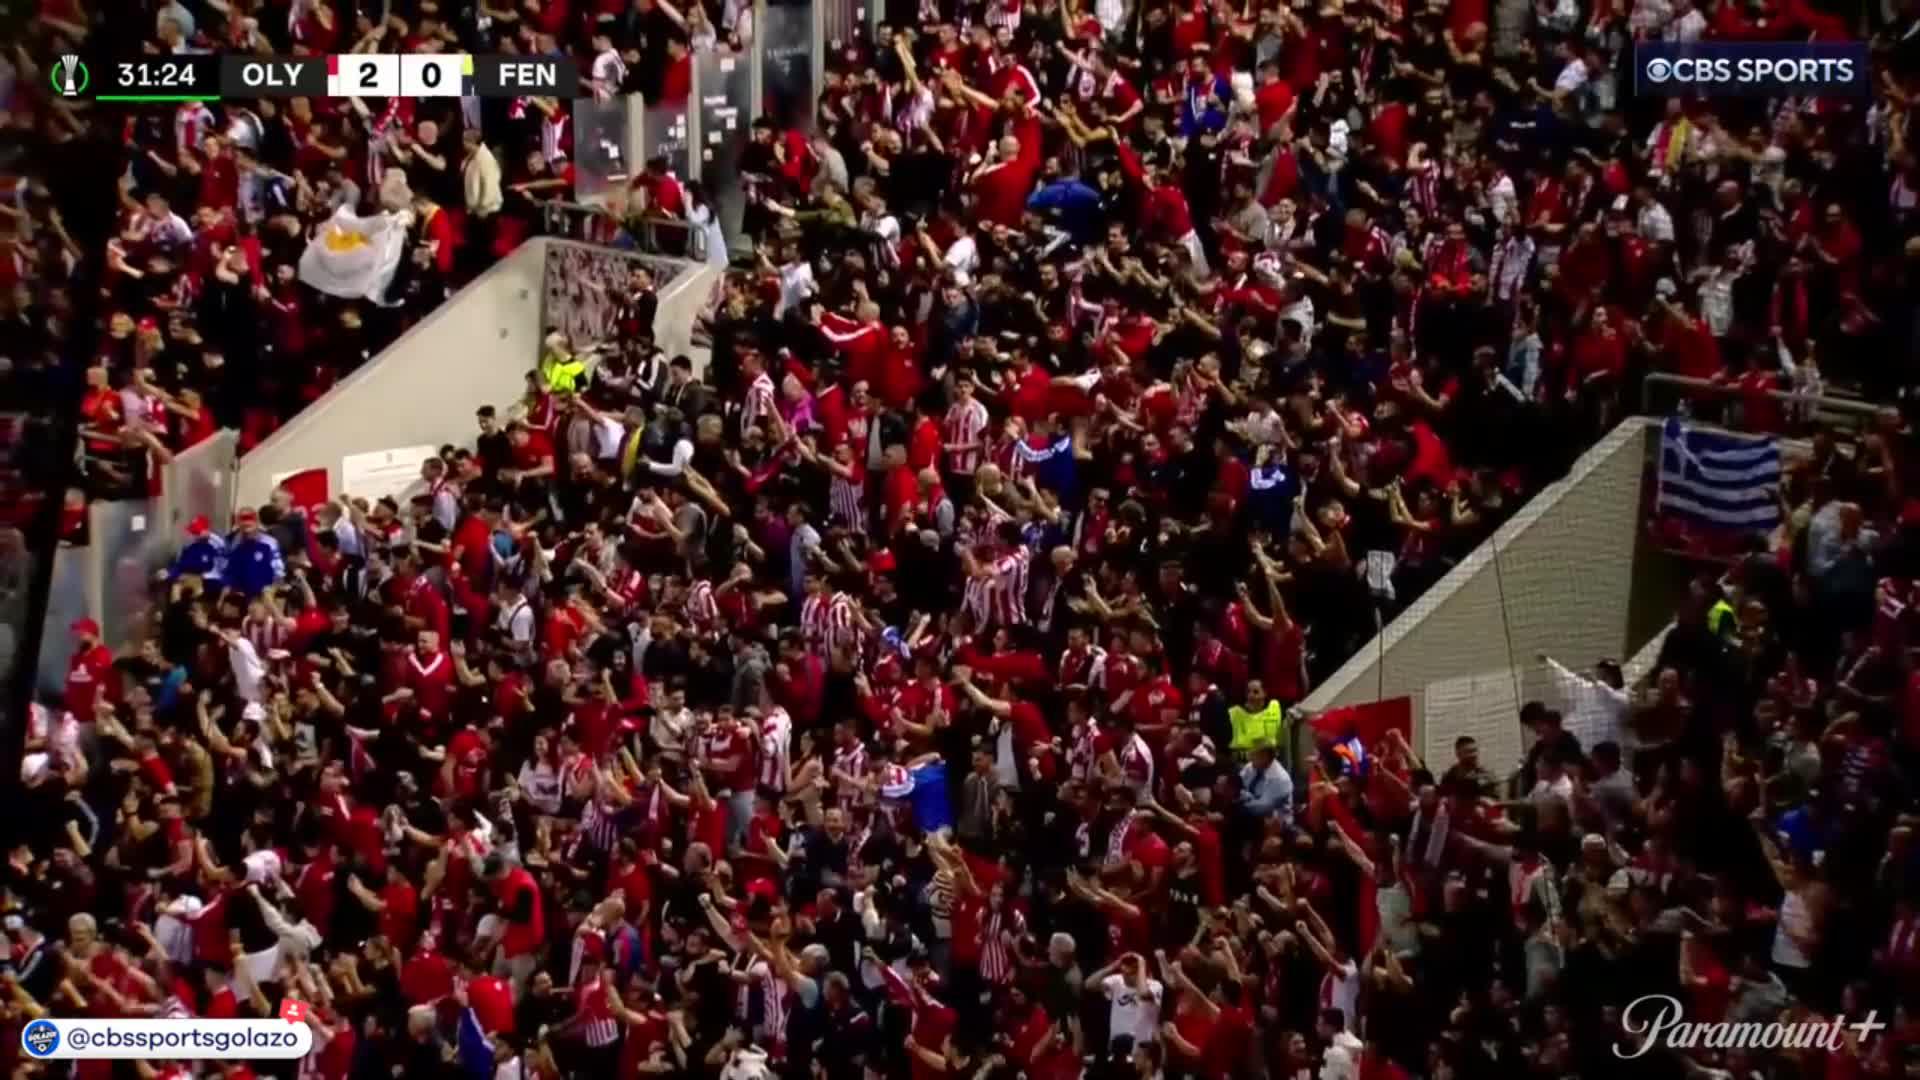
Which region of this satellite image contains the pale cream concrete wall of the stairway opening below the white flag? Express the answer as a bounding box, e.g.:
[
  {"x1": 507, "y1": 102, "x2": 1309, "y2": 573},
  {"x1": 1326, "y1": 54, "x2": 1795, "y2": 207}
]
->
[{"x1": 234, "y1": 238, "x2": 714, "y2": 505}]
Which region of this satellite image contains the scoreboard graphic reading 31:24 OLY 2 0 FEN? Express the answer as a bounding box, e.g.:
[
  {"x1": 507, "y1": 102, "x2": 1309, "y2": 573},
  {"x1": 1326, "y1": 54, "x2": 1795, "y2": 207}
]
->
[{"x1": 61, "y1": 52, "x2": 580, "y2": 102}]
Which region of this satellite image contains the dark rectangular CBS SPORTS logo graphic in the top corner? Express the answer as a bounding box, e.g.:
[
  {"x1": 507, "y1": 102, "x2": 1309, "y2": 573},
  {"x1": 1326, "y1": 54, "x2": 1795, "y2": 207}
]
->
[{"x1": 1634, "y1": 42, "x2": 1874, "y2": 98}]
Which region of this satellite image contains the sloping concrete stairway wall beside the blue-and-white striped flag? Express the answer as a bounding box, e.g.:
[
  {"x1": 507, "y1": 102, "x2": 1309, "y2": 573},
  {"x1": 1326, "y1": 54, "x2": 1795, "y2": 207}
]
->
[{"x1": 1304, "y1": 417, "x2": 1672, "y2": 774}]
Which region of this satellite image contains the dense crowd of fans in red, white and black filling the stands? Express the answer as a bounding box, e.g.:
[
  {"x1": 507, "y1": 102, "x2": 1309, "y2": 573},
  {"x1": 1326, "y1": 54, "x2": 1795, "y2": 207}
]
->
[{"x1": 0, "y1": 0, "x2": 1920, "y2": 1080}]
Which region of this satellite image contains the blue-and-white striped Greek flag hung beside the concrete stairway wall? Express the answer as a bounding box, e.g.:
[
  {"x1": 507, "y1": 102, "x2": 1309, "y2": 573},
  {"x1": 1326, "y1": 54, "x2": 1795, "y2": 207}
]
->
[{"x1": 1653, "y1": 419, "x2": 1780, "y2": 532}]
